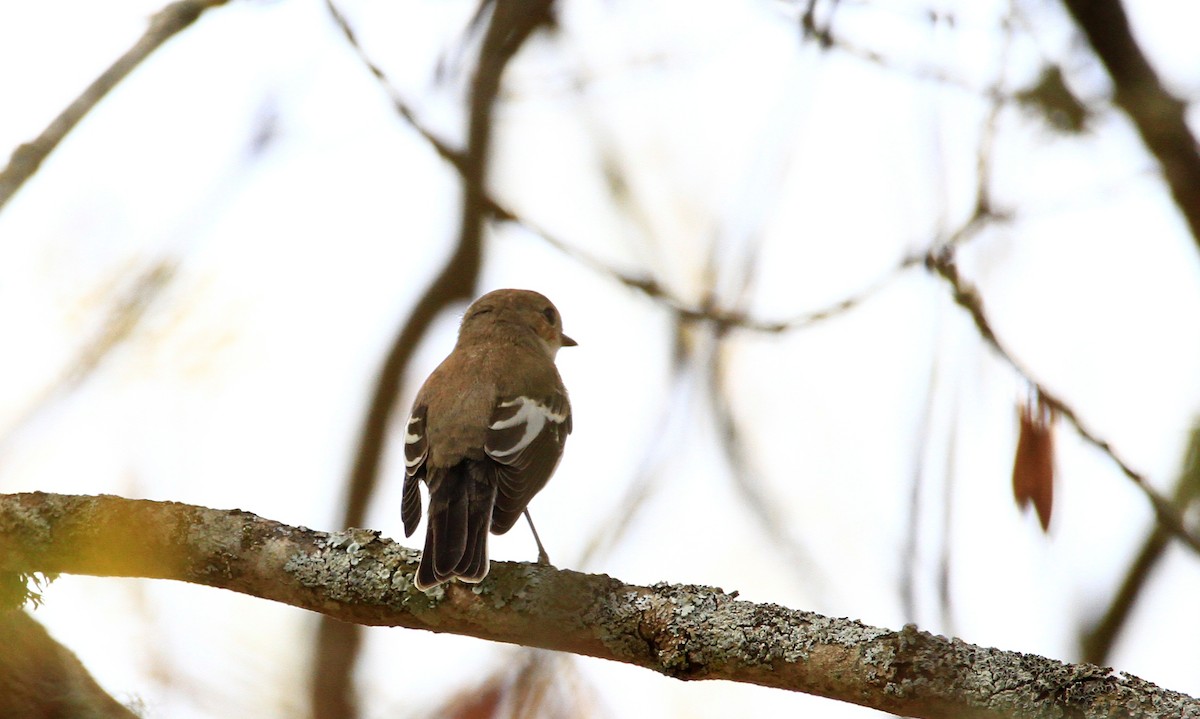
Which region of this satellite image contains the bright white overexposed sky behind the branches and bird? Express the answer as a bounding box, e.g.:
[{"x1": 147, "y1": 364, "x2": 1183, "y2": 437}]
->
[{"x1": 0, "y1": 0, "x2": 1200, "y2": 718}]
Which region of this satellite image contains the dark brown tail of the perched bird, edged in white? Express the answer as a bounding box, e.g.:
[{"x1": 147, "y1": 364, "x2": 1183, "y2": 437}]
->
[{"x1": 416, "y1": 461, "x2": 496, "y2": 591}]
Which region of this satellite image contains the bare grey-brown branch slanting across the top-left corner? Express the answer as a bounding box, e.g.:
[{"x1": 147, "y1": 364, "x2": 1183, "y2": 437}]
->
[{"x1": 0, "y1": 0, "x2": 227, "y2": 209}]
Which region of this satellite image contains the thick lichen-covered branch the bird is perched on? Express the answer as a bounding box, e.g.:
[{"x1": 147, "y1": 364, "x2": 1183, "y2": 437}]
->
[{"x1": 0, "y1": 492, "x2": 1200, "y2": 718}]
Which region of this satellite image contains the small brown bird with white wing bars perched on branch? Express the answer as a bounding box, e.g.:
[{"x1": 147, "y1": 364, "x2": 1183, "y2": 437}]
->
[{"x1": 401, "y1": 289, "x2": 577, "y2": 591}]
